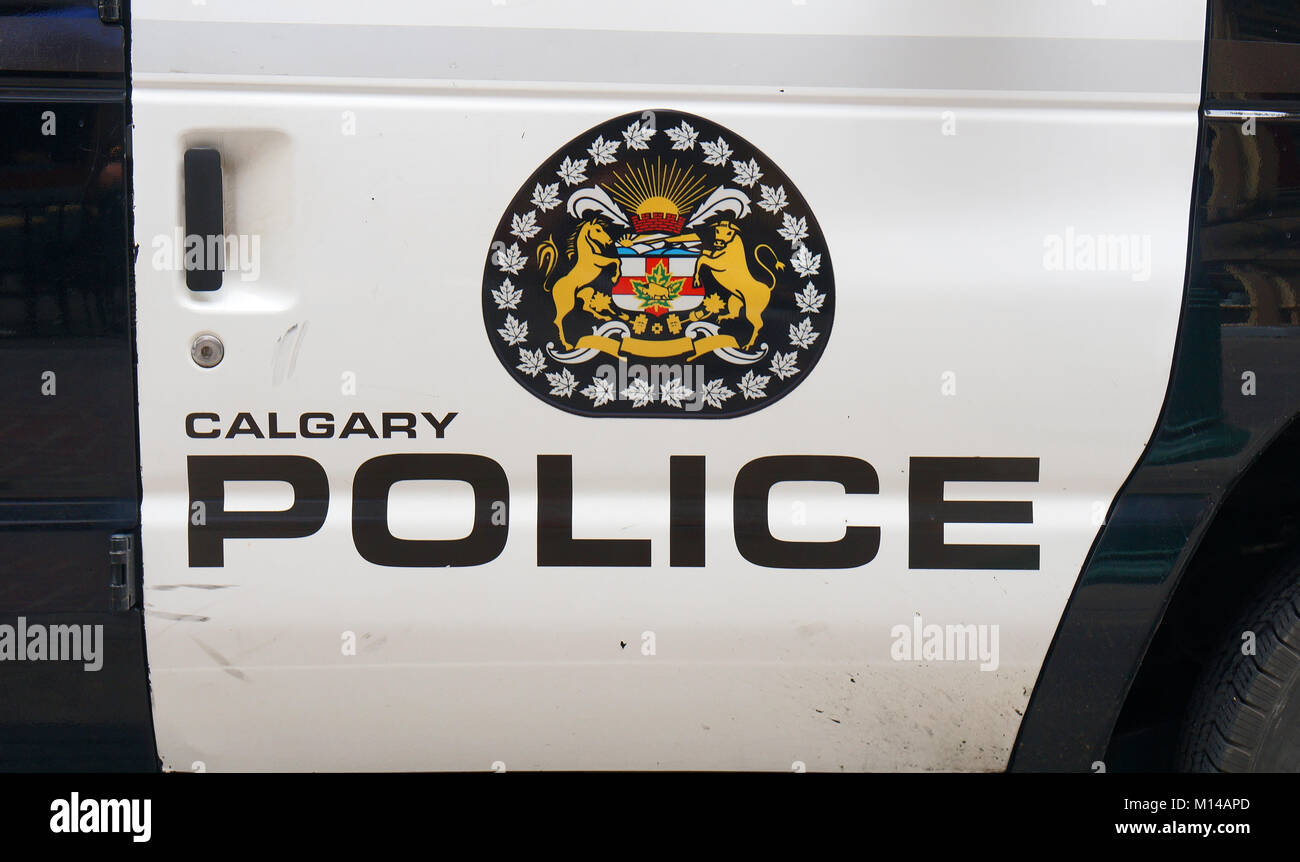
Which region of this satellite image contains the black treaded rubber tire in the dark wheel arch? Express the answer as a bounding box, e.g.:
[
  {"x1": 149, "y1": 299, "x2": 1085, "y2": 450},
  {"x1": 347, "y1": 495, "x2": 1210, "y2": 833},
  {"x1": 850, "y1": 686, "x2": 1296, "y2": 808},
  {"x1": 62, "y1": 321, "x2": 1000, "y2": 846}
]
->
[{"x1": 1179, "y1": 573, "x2": 1300, "y2": 772}]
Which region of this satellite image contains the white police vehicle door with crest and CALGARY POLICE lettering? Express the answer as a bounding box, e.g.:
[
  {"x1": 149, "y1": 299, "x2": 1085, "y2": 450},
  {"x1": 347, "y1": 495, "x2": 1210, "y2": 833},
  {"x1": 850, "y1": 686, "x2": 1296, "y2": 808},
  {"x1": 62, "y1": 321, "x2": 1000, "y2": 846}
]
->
[{"x1": 131, "y1": 0, "x2": 1204, "y2": 770}]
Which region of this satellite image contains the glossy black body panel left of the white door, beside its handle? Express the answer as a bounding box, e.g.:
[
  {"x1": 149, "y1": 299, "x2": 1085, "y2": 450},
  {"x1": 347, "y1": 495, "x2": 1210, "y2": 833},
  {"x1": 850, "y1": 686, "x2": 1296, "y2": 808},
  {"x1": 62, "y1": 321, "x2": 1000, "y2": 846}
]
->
[{"x1": 0, "y1": 0, "x2": 159, "y2": 771}]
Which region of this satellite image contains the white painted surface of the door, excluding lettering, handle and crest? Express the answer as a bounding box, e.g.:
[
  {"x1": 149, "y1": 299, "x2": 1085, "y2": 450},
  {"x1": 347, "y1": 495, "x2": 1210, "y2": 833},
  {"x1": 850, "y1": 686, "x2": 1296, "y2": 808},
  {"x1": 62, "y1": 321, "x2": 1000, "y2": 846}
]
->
[{"x1": 133, "y1": 0, "x2": 1205, "y2": 771}]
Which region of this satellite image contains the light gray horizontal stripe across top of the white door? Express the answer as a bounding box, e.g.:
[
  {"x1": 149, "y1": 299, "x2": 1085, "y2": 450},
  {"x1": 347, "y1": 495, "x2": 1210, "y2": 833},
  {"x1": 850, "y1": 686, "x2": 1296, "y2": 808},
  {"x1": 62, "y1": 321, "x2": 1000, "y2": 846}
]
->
[{"x1": 131, "y1": 20, "x2": 1201, "y2": 94}]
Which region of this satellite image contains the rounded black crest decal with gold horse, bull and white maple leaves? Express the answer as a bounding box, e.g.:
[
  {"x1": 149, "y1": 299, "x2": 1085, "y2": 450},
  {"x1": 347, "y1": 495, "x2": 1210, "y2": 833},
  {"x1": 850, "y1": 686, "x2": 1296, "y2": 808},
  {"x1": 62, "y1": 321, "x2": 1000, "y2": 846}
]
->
[{"x1": 484, "y1": 111, "x2": 835, "y2": 419}]
